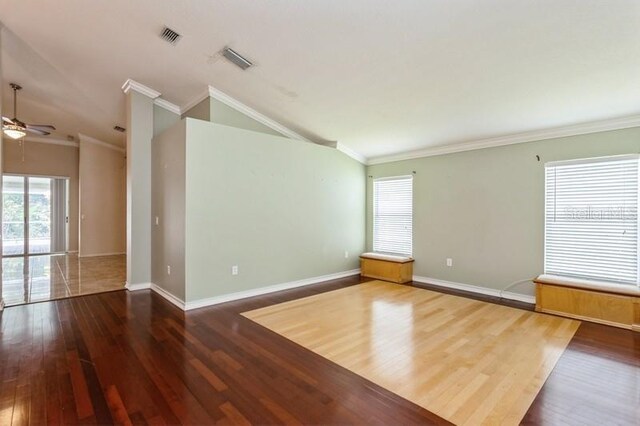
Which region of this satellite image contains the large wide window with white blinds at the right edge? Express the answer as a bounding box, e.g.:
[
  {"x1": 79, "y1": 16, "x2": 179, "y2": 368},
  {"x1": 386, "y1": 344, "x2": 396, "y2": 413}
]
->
[{"x1": 544, "y1": 155, "x2": 639, "y2": 285}]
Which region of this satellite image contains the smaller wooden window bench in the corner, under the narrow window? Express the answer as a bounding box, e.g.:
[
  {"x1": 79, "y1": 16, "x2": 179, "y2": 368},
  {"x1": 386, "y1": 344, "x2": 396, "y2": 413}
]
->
[{"x1": 360, "y1": 253, "x2": 413, "y2": 284}]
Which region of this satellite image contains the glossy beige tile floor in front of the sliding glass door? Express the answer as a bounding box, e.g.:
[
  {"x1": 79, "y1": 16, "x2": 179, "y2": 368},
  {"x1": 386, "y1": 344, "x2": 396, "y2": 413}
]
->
[{"x1": 2, "y1": 254, "x2": 126, "y2": 306}]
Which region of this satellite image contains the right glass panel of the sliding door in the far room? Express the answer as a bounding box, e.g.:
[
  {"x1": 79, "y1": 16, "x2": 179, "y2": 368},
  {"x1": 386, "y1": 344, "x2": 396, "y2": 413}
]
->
[{"x1": 28, "y1": 177, "x2": 52, "y2": 254}]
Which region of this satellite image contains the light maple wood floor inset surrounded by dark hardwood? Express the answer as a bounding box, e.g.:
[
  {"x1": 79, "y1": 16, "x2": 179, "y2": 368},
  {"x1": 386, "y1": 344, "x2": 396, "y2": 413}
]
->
[{"x1": 243, "y1": 281, "x2": 580, "y2": 425}]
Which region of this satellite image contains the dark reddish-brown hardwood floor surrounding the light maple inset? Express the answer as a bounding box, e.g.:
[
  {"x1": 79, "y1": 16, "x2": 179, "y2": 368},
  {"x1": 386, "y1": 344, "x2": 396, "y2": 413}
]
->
[{"x1": 0, "y1": 277, "x2": 640, "y2": 425}]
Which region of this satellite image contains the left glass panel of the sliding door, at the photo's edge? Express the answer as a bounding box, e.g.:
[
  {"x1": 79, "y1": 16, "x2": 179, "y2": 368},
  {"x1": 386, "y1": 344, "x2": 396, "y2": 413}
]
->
[{"x1": 2, "y1": 176, "x2": 26, "y2": 256}]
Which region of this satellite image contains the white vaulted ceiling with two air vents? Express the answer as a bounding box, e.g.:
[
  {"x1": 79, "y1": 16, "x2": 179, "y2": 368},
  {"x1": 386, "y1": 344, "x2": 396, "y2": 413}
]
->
[{"x1": 0, "y1": 0, "x2": 640, "y2": 157}]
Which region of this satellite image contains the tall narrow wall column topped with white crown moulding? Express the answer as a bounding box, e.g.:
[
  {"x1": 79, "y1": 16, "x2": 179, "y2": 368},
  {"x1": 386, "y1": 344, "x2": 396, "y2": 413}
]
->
[{"x1": 122, "y1": 80, "x2": 160, "y2": 290}]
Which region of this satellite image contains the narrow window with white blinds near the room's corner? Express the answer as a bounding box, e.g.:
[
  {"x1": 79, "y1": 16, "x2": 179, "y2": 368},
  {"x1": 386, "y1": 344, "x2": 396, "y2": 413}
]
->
[{"x1": 373, "y1": 176, "x2": 413, "y2": 256}]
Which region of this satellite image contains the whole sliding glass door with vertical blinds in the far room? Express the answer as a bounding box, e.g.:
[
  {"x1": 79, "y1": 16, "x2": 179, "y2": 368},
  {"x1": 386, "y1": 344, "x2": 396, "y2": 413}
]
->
[{"x1": 2, "y1": 175, "x2": 69, "y2": 257}]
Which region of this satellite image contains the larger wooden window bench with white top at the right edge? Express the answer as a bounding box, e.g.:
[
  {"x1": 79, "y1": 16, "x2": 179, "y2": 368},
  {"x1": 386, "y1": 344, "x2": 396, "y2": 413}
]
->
[{"x1": 534, "y1": 275, "x2": 640, "y2": 331}]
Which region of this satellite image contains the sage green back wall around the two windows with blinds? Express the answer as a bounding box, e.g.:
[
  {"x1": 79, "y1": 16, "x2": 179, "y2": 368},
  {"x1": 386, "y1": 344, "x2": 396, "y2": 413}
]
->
[{"x1": 367, "y1": 128, "x2": 640, "y2": 294}]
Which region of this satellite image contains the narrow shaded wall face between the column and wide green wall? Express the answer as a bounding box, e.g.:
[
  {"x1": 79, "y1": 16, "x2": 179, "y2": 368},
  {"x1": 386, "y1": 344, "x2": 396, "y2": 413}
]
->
[{"x1": 151, "y1": 120, "x2": 186, "y2": 300}]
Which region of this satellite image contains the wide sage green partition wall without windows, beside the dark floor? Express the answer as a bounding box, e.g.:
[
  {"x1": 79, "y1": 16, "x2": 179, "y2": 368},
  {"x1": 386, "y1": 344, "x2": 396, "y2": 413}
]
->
[{"x1": 185, "y1": 119, "x2": 366, "y2": 301}]
